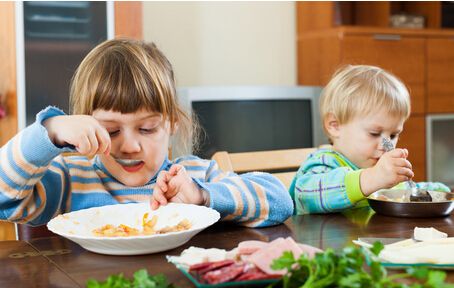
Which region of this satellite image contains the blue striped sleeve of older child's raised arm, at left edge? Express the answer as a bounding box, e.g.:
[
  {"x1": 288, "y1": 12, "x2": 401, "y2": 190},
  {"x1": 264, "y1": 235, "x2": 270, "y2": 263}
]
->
[{"x1": 0, "y1": 108, "x2": 72, "y2": 225}]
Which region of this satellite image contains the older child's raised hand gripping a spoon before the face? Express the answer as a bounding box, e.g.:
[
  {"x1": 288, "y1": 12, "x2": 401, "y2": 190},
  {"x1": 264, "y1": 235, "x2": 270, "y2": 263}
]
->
[{"x1": 43, "y1": 115, "x2": 111, "y2": 156}]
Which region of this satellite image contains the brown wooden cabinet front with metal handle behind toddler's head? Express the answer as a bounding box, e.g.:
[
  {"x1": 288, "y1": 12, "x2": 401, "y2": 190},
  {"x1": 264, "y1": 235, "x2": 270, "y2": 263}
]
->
[{"x1": 341, "y1": 35, "x2": 426, "y2": 114}]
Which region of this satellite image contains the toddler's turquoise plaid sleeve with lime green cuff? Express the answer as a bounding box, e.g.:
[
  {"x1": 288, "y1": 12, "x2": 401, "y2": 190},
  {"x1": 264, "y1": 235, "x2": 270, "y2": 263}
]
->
[{"x1": 290, "y1": 157, "x2": 364, "y2": 214}]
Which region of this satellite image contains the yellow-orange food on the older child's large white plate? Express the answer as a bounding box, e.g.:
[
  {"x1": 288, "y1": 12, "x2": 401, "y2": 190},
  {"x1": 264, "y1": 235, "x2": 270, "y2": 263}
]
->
[{"x1": 93, "y1": 213, "x2": 192, "y2": 237}]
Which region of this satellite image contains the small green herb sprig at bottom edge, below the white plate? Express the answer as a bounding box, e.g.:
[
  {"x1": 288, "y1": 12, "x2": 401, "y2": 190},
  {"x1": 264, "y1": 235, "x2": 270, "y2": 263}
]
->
[{"x1": 87, "y1": 269, "x2": 174, "y2": 288}]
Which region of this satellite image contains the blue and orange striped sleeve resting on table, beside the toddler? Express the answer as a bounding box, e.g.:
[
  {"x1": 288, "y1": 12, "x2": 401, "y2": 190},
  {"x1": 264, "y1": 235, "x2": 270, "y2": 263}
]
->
[{"x1": 176, "y1": 157, "x2": 293, "y2": 227}]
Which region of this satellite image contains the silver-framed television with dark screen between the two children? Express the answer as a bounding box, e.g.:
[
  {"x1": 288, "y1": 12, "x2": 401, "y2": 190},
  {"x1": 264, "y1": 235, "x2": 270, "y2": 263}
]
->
[{"x1": 178, "y1": 86, "x2": 326, "y2": 159}]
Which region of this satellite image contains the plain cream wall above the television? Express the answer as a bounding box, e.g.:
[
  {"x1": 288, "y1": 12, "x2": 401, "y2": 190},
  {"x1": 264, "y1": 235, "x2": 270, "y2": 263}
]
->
[{"x1": 143, "y1": 2, "x2": 296, "y2": 86}]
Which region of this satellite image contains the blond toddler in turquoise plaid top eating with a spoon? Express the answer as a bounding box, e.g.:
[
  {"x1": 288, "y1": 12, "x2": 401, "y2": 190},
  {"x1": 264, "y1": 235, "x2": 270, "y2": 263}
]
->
[{"x1": 290, "y1": 65, "x2": 449, "y2": 214}]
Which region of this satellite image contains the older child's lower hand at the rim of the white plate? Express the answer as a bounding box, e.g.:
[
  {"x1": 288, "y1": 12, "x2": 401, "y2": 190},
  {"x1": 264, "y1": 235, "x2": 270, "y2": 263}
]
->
[{"x1": 150, "y1": 164, "x2": 208, "y2": 210}]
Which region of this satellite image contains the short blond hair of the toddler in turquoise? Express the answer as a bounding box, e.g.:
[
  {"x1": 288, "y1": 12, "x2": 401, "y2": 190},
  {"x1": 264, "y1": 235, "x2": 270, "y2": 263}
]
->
[{"x1": 320, "y1": 65, "x2": 411, "y2": 136}]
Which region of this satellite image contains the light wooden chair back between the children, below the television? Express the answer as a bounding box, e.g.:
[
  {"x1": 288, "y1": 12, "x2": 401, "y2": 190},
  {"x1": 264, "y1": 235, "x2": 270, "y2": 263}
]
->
[{"x1": 212, "y1": 148, "x2": 317, "y2": 189}]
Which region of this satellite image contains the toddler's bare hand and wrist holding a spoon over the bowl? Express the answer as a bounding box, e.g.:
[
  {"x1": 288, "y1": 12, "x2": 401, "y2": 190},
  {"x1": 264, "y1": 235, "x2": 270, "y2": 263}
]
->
[{"x1": 360, "y1": 149, "x2": 414, "y2": 196}]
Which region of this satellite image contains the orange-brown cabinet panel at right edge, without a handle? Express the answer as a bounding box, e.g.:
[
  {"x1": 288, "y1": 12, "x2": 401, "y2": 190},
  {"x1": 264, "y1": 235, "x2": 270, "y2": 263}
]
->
[{"x1": 427, "y1": 38, "x2": 454, "y2": 113}]
